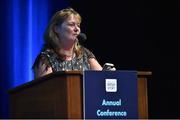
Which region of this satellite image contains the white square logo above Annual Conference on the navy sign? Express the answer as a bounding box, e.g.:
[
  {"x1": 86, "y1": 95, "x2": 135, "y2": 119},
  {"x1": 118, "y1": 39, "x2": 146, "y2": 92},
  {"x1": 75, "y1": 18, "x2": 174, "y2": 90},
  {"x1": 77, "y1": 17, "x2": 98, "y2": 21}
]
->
[{"x1": 105, "y1": 79, "x2": 117, "y2": 92}]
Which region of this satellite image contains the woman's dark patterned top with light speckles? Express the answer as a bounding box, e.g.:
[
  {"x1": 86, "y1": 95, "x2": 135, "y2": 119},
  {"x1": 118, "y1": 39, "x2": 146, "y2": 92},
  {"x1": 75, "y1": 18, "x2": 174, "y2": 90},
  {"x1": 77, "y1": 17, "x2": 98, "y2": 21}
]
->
[{"x1": 32, "y1": 47, "x2": 95, "y2": 72}]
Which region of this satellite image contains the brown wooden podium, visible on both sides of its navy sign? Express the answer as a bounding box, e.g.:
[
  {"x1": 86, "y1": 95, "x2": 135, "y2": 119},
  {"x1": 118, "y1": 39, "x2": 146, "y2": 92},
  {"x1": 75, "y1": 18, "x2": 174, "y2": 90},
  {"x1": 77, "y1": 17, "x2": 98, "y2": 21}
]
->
[{"x1": 9, "y1": 71, "x2": 151, "y2": 119}]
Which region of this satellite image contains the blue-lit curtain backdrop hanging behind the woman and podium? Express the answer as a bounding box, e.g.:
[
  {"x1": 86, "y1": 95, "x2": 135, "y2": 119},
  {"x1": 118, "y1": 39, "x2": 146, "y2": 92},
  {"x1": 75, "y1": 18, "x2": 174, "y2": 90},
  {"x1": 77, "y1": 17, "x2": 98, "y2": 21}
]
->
[{"x1": 0, "y1": 0, "x2": 69, "y2": 118}]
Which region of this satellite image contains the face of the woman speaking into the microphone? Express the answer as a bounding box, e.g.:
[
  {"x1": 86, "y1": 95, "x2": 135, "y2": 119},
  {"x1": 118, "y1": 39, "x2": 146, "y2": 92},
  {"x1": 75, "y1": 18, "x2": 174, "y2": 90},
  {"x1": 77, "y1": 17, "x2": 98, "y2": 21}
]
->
[{"x1": 56, "y1": 15, "x2": 81, "y2": 42}]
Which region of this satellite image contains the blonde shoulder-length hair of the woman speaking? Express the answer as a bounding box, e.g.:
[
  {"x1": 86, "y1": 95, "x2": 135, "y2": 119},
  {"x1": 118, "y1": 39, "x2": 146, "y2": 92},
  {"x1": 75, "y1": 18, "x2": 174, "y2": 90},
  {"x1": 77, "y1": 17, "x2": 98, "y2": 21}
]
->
[{"x1": 44, "y1": 7, "x2": 82, "y2": 56}]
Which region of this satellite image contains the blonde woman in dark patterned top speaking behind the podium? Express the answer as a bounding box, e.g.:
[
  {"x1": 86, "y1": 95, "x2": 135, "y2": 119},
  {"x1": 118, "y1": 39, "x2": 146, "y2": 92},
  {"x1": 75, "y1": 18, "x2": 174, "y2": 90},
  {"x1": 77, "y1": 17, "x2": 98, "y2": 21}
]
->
[{"x1": 32, "y1": 8, "x2": 102, "y2": 78}]
